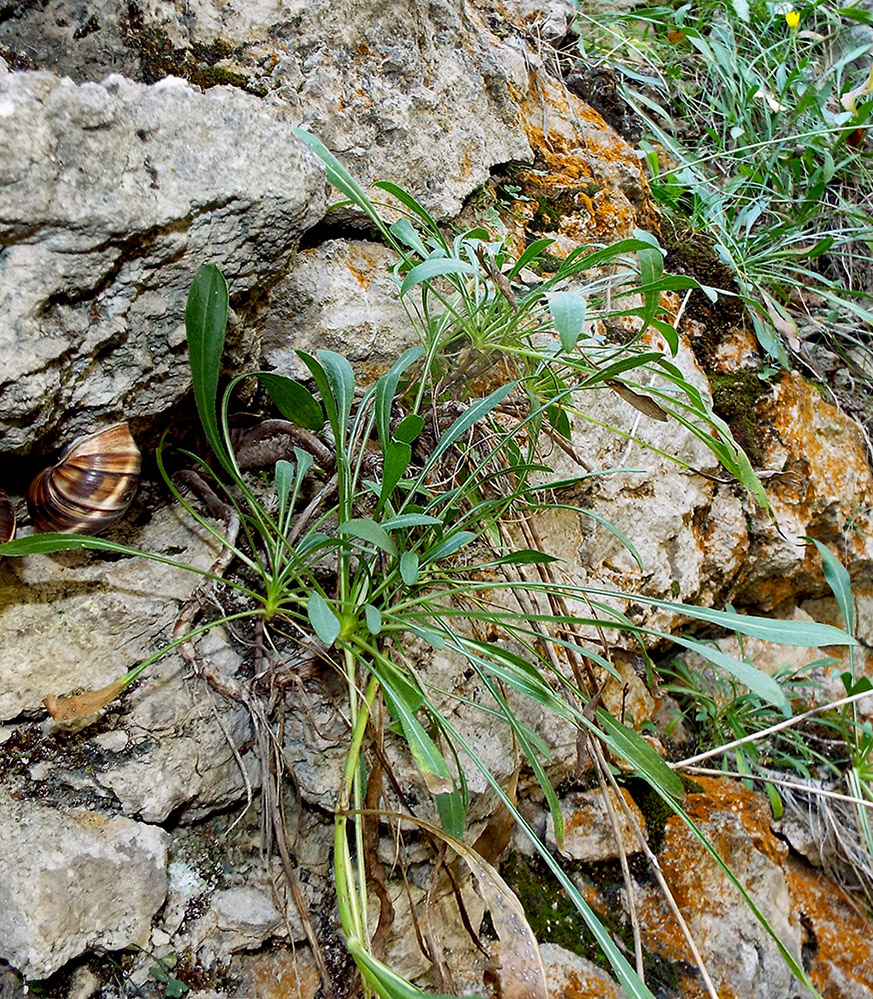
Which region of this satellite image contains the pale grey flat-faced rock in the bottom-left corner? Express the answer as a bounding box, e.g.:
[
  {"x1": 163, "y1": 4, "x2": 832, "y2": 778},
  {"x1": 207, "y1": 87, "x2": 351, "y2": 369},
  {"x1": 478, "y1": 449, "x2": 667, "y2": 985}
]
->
[{"x1": 0, "y1": 796, "x2": 169, "y2": 978}]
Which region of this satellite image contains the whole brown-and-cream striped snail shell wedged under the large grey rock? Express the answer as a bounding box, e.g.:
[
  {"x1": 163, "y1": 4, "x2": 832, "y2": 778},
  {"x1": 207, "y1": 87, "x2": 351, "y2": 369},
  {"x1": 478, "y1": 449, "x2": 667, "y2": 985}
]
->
[{"x1": 27, "y1": 423, "x2": 142, "y2": 534}]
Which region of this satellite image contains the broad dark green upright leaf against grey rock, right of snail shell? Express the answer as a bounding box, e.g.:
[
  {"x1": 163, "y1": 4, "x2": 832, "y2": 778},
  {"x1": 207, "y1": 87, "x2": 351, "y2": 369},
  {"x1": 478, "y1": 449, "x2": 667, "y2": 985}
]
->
[{"x1": 185, "y1": 264, "x2": 229, "y2": 468}]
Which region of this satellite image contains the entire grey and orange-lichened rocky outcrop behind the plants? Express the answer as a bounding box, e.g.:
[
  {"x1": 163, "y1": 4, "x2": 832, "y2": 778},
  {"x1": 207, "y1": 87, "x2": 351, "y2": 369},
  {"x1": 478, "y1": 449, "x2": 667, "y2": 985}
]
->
[{"x1": 0, "y1": 0, "x2": 873, "y2": 999}]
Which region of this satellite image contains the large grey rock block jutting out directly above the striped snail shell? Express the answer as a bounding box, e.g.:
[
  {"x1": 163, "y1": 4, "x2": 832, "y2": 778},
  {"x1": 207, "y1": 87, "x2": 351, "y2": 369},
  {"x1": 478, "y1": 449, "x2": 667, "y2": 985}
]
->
[{"x1": 0, "y1": 73, "x2": 325, "y2": 451}]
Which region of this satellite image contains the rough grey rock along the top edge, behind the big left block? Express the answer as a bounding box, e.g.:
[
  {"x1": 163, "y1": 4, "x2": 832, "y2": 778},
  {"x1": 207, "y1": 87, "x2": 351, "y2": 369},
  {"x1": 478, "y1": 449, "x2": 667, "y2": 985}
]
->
[{"x1": 0, "y1": 0, "x2": 530, "y2": 218}]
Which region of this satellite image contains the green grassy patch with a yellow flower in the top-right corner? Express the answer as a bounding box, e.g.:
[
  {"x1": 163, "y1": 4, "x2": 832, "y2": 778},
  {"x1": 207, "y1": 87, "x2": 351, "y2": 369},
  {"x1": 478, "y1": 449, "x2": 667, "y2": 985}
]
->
[{"x1": 567, "y1": 0, "x2": 873, "y2": 366}]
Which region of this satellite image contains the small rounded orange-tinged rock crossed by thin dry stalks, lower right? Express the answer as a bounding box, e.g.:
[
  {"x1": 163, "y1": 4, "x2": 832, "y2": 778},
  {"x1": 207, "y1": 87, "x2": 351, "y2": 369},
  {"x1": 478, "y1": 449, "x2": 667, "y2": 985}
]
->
[{"x1": 546, "y1": 789, "x2": 646, "y2": 864}]
